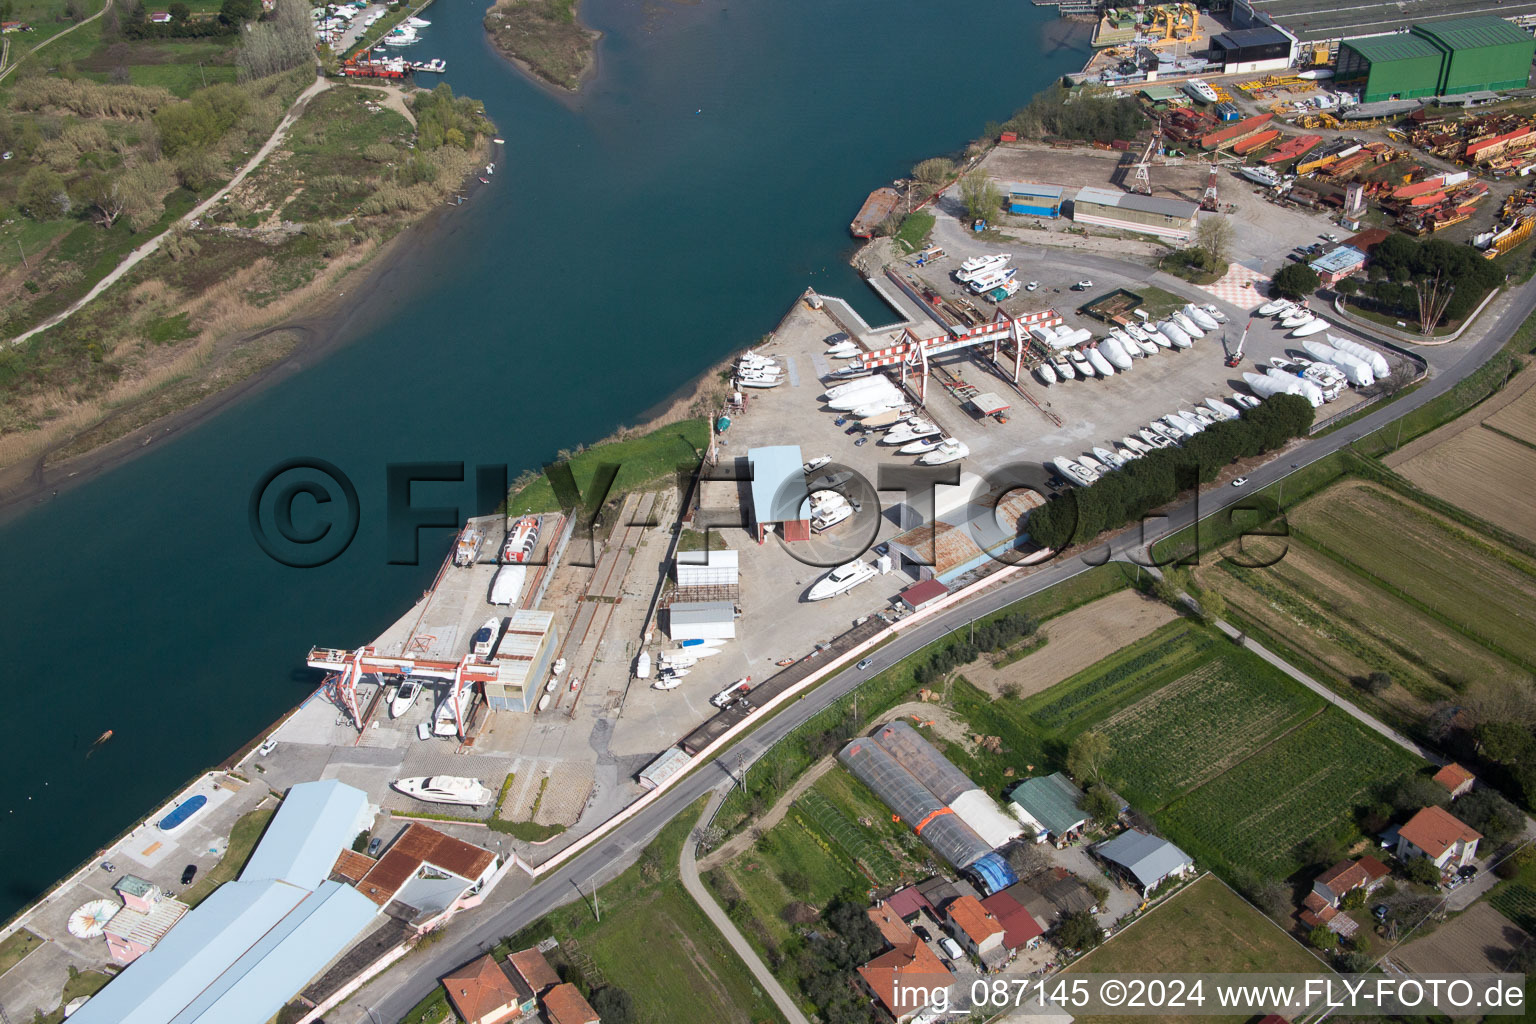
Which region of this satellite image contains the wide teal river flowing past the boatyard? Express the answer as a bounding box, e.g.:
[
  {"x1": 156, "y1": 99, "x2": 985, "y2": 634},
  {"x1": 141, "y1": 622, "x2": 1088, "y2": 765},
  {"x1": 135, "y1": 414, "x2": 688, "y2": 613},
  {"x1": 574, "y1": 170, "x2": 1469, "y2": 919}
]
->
[{"x1": 0, "y1": 0, "x2": 1084, "y2": 920}]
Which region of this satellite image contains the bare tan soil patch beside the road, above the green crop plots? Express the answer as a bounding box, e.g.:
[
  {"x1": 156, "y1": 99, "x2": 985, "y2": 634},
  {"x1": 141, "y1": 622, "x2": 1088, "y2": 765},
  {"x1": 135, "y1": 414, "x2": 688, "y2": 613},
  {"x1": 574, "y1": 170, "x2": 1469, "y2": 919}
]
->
[{"x1": 960, "y1": 590, "x2": 1177, "y2": 697}]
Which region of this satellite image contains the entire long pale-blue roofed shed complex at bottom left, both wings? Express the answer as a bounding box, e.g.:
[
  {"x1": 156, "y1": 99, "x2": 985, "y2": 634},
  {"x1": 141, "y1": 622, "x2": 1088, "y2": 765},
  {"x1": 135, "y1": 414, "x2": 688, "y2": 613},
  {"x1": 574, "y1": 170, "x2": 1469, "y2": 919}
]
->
[{"x1": 69, "y1": 780, "x2": 379, "y2": 1024}]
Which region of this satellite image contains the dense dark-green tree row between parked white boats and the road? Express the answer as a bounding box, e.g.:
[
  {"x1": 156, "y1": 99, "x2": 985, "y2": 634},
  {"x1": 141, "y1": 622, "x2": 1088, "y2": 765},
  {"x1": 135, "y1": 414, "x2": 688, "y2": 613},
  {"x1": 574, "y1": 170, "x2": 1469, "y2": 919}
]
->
[{"x1": 1029, "y1": 395, "x2": 1313, "y2": 551}]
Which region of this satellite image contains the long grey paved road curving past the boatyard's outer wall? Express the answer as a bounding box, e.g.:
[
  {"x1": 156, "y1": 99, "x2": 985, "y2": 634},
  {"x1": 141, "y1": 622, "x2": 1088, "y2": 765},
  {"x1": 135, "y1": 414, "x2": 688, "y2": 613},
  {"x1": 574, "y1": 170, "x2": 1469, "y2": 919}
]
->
[{"x1": 348, "y1": 250, "x2": 1536, "y2": 1024}]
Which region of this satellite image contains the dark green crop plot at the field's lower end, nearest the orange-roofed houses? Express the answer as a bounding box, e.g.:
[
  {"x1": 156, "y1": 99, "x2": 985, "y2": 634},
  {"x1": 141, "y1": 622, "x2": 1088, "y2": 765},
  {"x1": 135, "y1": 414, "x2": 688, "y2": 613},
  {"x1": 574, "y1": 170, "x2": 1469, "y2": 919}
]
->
[{"x1": 1157, "y1": 708, "x2": 1419, "y2": 878}]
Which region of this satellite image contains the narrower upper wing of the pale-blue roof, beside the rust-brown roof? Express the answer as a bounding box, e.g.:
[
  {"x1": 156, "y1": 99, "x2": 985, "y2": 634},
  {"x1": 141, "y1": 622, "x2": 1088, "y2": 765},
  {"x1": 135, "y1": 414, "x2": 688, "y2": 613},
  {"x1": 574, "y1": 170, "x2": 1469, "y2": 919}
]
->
[{"x1": 240, "y1": 778, "x2": 369, "y2": 889}]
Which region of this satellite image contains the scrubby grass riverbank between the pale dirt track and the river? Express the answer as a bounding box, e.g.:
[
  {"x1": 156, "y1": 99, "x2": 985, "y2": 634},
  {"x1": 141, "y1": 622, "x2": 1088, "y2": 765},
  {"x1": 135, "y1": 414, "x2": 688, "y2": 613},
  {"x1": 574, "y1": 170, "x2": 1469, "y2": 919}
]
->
[{"x1": 0, "y1": 86, "x2": 499, "y2": 508}]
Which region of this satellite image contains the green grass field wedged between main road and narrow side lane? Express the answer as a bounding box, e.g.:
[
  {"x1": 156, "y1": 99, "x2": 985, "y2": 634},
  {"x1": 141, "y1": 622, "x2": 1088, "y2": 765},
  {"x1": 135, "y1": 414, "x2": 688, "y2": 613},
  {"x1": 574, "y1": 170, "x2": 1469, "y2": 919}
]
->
[{"x1": 496, "y1": 798, "x2": 782, "y2": 1024}]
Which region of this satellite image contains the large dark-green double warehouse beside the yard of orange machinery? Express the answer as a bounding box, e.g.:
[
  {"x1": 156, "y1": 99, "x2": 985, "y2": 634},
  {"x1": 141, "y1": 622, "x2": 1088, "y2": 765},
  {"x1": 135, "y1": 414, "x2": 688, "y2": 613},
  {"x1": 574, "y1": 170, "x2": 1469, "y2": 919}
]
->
[{"x1": 1335, "y1": 15, "x2": 1536, "y2": 103}]
